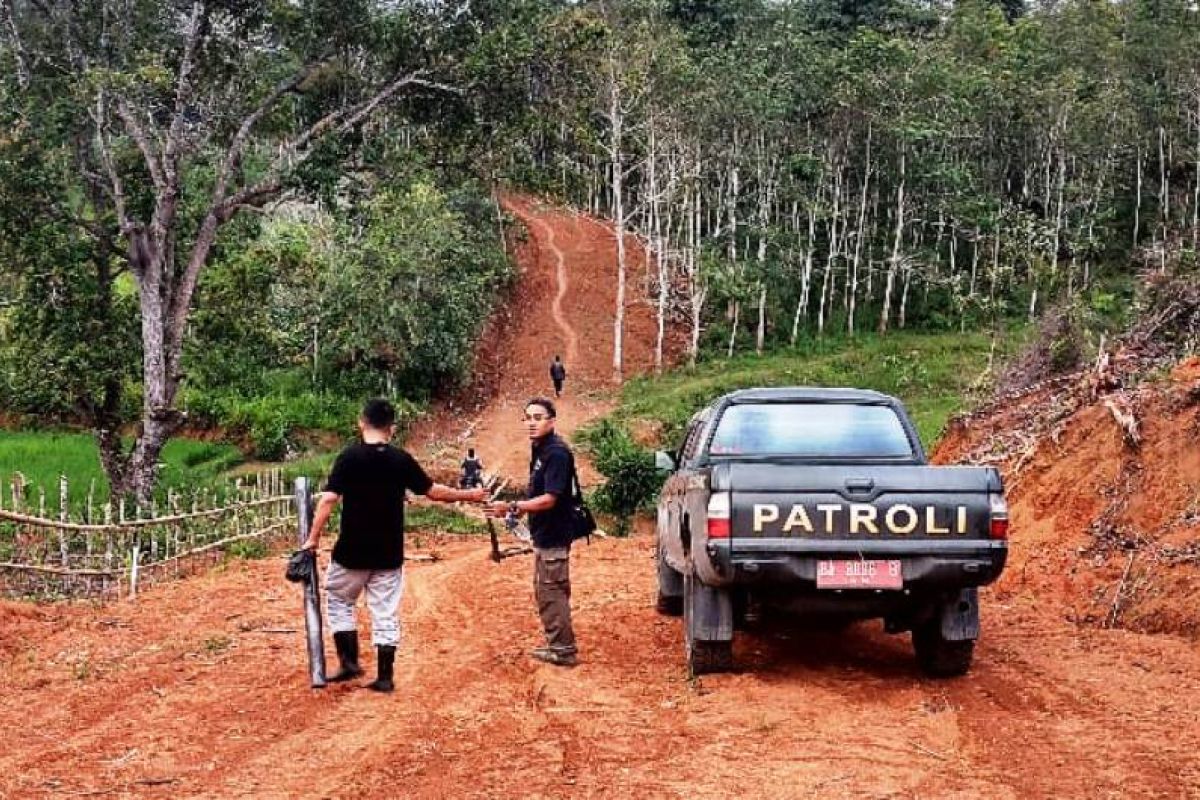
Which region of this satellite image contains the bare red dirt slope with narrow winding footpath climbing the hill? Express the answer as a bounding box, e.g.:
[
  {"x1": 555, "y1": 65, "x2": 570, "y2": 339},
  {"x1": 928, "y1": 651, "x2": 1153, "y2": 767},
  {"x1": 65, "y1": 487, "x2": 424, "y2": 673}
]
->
[{"x1": 409, "y1": 194, "x2": 685, "y2": 485}]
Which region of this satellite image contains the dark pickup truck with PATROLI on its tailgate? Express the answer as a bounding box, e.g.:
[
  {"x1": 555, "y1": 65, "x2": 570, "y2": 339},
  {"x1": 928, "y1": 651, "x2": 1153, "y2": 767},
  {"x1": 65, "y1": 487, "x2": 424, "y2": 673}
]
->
[{"x1": 655, "y1": 387, "x2": 1008, "y2": 676}]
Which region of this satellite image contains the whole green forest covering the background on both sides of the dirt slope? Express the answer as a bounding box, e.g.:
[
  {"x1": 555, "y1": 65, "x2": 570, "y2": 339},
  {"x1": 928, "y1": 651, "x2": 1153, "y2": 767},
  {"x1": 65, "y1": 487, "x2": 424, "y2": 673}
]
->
[{"x1": 0, "y1": 0, "x2": 1200, "y2": 497}]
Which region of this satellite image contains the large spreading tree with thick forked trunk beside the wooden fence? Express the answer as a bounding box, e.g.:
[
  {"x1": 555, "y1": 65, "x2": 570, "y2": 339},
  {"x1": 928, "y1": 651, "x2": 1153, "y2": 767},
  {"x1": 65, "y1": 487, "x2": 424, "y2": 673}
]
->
[{"x1": 0, "y1": 0, "x2": 452, "y2": 499}]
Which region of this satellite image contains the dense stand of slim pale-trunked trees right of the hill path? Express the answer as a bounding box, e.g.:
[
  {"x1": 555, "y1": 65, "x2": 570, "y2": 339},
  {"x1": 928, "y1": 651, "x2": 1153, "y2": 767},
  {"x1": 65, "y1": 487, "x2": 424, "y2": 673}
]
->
[{"x1": 484, "y1": 0, "x2": 1200, "y2": 355}]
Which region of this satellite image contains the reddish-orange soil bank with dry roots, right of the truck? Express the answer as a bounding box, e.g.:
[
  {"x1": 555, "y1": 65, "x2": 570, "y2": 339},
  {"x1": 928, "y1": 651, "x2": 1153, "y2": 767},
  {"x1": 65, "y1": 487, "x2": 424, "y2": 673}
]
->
[{"x1": 934, "y1": 357, "x2": 1200, "y2": 637}]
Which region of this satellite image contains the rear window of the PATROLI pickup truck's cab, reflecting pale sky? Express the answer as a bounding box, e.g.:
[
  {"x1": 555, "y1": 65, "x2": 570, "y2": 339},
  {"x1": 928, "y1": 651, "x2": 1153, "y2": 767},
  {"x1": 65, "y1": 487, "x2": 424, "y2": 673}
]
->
[{"x1": 708, "y1": 403, "x2": 913, "y2": 458}]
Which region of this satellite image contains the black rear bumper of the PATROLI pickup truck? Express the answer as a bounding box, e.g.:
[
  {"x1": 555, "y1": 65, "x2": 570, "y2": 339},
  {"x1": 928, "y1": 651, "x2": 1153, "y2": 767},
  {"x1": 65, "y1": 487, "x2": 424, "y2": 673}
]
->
[{"x1": 703, "y1": 539, "x2": 1008, "y2": 594}]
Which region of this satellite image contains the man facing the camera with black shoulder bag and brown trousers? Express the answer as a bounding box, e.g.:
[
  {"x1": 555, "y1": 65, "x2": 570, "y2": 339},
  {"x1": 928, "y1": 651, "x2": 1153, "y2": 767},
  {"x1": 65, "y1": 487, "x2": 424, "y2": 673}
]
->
[{"x1": 487, "y1": 397, "x2": 578, "y2": 667}]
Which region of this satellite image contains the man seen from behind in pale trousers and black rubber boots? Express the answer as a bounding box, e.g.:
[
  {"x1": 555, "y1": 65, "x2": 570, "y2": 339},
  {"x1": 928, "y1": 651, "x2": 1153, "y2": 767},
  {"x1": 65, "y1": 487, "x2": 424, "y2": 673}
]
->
[{"x1": 304, "y1": 399, "x2": 487, "y2": 692}]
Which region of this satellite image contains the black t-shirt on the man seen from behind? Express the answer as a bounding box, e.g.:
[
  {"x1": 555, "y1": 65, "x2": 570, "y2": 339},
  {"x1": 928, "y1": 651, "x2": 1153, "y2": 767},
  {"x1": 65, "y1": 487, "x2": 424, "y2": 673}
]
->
[{"x1": 325, "y1": 441, "x2": 433, "y2": 570}]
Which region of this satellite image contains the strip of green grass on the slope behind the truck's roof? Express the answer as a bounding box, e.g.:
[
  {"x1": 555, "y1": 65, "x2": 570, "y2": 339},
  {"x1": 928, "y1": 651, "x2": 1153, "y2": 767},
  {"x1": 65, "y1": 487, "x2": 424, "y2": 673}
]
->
[{"x1": 613, "y1": 331, "x2": 1025, "y2": 447}]
